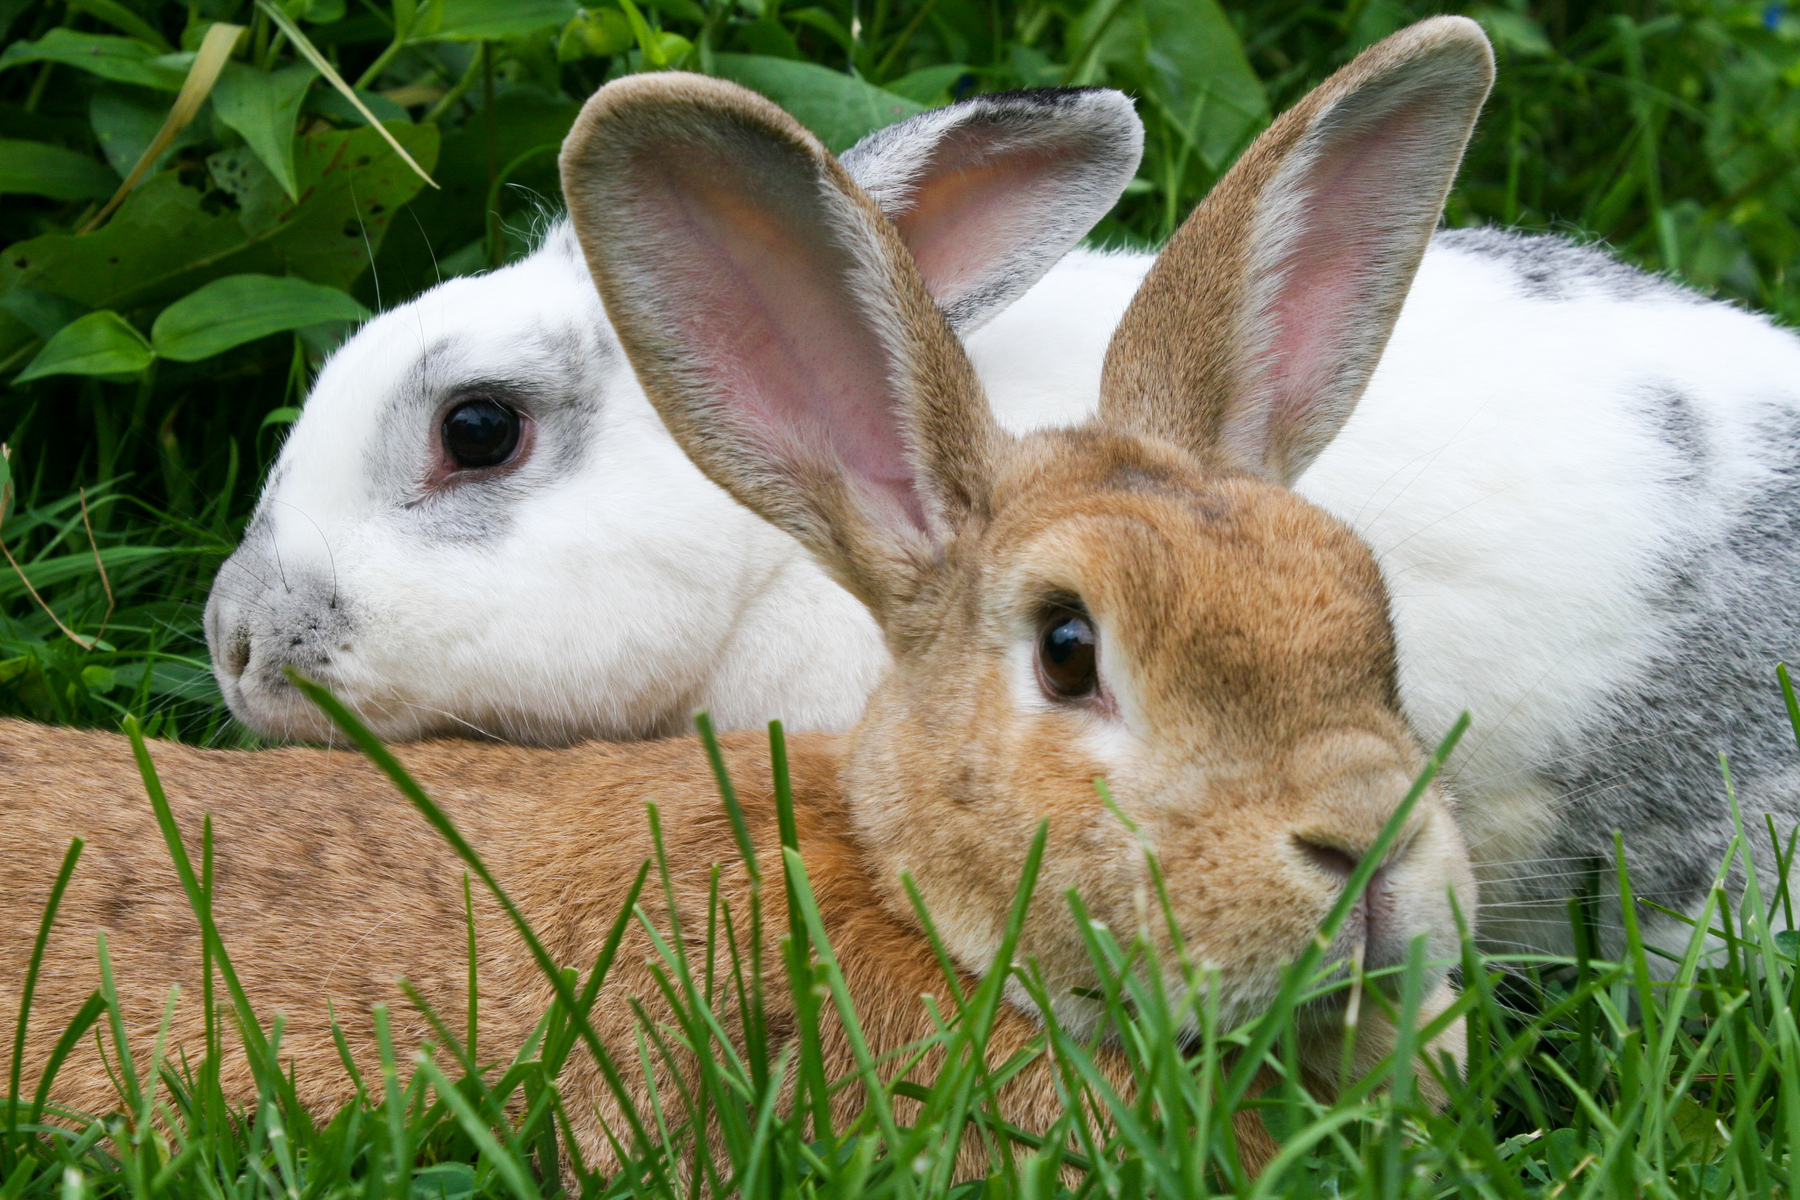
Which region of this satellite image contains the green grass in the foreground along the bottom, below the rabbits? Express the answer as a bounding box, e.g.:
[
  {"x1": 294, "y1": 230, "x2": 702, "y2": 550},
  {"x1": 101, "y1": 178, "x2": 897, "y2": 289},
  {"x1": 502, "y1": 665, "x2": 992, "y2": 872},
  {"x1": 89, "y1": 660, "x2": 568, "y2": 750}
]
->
[{"x1": 0, "y1": 700, "x2": 1800, "y2": 1200}]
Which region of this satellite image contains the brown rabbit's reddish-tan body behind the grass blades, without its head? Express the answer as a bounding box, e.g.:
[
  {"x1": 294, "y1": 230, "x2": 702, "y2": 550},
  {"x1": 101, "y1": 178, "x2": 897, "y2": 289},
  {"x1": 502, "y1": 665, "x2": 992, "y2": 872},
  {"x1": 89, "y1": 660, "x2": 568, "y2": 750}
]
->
[{"x1": 0, "y1": 721, "x2": 1087, "y2": 1164}]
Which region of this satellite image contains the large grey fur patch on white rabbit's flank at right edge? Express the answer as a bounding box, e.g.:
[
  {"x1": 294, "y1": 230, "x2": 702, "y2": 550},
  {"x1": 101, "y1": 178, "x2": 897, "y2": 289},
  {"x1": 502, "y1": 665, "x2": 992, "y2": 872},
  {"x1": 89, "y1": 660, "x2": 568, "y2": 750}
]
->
[{"x1": 1532, "y1": 403, "x2": 1800, "y2": 939}]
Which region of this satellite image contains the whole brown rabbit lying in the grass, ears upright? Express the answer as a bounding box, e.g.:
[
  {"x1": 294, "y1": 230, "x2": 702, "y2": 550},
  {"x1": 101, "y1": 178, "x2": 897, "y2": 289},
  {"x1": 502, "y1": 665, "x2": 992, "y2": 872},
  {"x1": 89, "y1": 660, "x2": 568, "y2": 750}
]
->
[{"x1": 0, "y1": 18, "x2": 1492, "y2": 1166}]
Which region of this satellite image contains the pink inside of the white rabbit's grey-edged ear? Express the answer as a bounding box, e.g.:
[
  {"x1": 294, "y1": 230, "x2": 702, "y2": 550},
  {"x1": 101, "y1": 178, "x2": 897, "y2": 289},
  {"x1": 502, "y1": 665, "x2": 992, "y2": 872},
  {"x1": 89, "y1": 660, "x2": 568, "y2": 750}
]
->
[{"x1": 895, "y1": 131, "x2": 1064, "y2": 308}]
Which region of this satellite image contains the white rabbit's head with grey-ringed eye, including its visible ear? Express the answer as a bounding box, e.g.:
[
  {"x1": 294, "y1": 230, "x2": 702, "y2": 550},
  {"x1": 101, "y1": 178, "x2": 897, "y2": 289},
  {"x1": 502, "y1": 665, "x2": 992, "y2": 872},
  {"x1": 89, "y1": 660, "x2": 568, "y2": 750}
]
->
[{"x1": 207, "y1": 90, "x2": 1141, "y2": 743}]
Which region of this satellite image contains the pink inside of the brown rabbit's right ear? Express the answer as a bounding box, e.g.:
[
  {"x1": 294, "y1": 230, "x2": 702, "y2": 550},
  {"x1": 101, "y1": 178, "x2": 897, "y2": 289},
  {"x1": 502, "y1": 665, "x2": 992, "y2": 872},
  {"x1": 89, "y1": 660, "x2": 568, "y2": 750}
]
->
[{"x1": 1256, "y1": 113, "x2": 1427, "y2": 455}]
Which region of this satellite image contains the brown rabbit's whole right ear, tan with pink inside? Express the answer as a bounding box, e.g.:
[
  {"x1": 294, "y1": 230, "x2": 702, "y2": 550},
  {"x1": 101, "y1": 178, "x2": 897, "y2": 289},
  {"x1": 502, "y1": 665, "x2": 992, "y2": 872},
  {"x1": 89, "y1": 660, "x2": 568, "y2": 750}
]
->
[{"x1": 1100, "y1": 16, "x2": 1494, "y2": 484}]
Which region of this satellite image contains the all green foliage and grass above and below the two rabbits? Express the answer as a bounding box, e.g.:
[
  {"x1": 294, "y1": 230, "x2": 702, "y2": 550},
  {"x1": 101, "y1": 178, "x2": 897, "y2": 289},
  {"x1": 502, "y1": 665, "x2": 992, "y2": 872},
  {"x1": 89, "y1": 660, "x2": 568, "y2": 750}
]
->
[{"x1": 0, "y1": 0, "x2": 1800, "y2": 1200}]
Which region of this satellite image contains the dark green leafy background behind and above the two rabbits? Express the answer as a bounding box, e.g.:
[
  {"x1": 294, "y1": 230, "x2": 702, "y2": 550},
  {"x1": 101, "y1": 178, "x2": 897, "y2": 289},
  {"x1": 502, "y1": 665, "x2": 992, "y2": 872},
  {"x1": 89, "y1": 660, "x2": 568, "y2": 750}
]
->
[{"x1": 0, "y1": 0, "x2": 1800, "y2": 741}]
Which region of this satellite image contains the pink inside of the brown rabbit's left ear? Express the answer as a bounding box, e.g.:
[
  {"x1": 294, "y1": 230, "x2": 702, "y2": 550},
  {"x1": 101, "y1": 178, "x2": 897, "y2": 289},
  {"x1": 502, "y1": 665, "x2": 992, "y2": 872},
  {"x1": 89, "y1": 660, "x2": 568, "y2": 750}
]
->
[{"x1": 646, "y1": 164, "x2": 929, "y2": 531}]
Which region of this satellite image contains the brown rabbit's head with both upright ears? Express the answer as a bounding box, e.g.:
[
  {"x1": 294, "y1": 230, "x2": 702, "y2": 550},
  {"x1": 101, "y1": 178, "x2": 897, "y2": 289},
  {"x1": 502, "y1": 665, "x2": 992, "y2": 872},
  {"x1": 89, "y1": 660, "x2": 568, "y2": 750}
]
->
[{"x1": 563, "y1": 18, "x2": 1492, "y2": 1043}]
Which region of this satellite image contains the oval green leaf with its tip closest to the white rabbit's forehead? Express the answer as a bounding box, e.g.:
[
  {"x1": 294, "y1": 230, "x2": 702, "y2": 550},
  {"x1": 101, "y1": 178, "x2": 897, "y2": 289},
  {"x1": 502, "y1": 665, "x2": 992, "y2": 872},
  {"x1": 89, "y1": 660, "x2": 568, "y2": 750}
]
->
[{"x1": 149, "y1": 275, "x2": 369, "y2": 362}]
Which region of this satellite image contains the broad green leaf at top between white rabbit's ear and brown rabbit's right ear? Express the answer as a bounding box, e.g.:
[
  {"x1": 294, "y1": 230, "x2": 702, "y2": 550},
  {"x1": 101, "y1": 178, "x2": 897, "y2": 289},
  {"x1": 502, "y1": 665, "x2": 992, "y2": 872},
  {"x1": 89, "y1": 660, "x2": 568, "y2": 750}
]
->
[{"x1": 1139, "y1": 0, "x2": 1269, "y2": 171}]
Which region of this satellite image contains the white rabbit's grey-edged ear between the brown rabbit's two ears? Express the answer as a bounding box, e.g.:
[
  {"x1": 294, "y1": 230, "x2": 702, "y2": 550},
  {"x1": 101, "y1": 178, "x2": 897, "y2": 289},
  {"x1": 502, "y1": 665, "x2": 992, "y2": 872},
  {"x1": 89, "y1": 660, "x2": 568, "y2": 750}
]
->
[{"x1": 842, "y1": 88, "x2": 1143, "y2": 336}]
